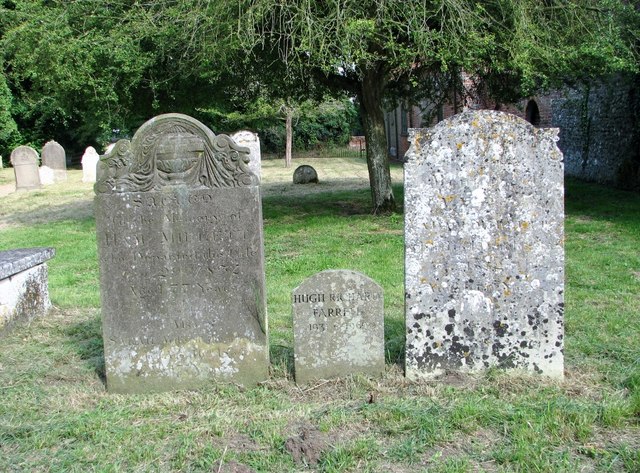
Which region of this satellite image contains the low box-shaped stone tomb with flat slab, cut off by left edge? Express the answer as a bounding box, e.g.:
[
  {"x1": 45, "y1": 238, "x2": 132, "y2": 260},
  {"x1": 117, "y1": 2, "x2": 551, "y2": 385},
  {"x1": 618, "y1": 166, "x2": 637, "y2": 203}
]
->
[{"x1": 0, "y1": 248, "x2": 55, "y2": 333}]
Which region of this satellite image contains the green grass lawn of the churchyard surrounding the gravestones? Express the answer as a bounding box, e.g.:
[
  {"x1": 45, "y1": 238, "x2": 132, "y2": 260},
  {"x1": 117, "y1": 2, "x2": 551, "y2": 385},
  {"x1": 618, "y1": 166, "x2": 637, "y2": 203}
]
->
[{"x1": 0, "y1": 158, "x2": 640, "y2": 473}]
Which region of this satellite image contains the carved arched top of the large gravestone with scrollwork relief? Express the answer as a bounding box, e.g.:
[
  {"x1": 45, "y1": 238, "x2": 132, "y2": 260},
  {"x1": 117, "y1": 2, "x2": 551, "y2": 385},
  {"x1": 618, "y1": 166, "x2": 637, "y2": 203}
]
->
[{"x1": 96, "y1": 113, "x2": 257, "y2": 193}]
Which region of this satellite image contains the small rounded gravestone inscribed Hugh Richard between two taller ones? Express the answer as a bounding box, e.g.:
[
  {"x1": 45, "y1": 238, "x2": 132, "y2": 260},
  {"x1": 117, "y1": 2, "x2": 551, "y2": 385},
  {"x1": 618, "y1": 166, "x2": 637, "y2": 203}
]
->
[{"x1": 291, "y1": 270, "x2": 384, "y2": 384}]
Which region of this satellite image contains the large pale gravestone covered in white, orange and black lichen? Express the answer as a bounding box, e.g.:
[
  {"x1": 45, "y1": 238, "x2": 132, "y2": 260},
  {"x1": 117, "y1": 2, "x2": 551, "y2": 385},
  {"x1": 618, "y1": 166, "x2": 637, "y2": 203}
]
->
[{"x1": 404, "y1": 111, "x2": 564, "y2": 379}]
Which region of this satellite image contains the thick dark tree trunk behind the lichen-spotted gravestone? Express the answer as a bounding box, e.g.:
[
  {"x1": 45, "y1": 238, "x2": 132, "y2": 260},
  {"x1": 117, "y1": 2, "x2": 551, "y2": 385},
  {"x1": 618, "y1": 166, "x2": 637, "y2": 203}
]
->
[{"x1": 359, "y1": 68, "x2": 396, "y2": 213}]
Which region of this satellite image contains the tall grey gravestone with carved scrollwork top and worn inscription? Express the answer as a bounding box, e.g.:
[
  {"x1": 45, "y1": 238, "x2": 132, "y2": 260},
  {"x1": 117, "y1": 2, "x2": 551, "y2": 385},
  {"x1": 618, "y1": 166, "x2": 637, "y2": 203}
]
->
[{"x1": 95, "y1": 114, "x2": 269, "y2": 393}]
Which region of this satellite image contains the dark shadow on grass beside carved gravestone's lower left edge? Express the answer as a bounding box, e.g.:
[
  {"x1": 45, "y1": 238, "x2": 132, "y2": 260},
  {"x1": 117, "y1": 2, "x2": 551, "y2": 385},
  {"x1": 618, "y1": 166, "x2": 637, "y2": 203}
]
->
[{"x1": 65, "y1": 313, "x2": 107, "y2": 386}]
